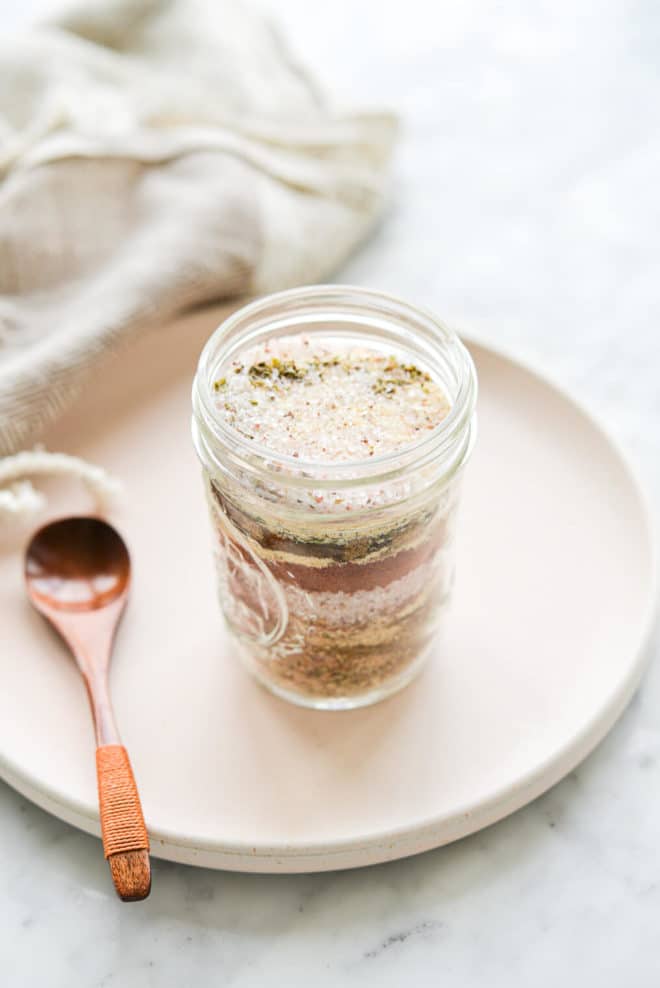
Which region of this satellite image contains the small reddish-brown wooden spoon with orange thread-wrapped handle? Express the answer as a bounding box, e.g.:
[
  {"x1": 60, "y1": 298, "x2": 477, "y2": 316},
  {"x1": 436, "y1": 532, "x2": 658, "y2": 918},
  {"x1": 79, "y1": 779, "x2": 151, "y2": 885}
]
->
[{"x1": 25, "y1": 518, "x2": 151, "y2": 902}]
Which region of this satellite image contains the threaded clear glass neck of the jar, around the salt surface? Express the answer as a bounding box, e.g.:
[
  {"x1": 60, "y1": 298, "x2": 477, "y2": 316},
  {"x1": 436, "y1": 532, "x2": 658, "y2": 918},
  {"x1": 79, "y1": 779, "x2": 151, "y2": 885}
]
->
[{"x1": 193, "y1": 285, "x2": 477, "y2": 502}]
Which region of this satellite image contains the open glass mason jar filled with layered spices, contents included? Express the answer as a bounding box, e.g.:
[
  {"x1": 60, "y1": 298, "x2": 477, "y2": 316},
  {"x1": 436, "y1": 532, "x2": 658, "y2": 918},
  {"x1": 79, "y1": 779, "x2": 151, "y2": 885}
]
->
[{"x1": 193, "y1": 286, "x2": 477, "y2": 709}]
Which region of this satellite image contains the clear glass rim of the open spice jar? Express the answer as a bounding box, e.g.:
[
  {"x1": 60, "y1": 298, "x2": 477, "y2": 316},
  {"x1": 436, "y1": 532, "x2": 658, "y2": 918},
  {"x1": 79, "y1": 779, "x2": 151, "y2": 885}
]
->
[{"x1": 192, "y1": 284, "x2": 478, "y2": 488}]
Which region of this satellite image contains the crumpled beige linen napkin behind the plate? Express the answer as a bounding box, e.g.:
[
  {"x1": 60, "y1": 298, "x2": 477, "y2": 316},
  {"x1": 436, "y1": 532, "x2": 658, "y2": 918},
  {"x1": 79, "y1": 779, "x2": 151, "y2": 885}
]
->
[{"x1": 0, "y1": 0, "x2": 395, "y2": 510}]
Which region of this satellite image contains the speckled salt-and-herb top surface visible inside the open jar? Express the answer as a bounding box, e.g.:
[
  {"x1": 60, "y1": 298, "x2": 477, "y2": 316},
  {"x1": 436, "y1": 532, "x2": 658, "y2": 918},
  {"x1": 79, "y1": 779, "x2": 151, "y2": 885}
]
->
[{"x1": 214, "y1": 334, "x2": 450, "y2": 463}]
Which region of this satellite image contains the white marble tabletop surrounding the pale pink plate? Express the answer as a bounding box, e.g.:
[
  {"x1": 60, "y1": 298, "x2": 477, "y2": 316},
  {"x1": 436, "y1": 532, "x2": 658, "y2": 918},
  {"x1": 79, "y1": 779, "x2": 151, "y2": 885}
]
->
[{"x1": 0, "y1": 0, "x2": 660, "y2": 988}]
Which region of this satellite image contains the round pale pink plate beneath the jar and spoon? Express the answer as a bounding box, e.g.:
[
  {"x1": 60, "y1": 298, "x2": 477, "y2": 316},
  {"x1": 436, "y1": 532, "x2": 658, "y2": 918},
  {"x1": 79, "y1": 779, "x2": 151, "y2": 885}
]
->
[{"x1": 0, "y1": 310, "x2": 656, "y2": 872}]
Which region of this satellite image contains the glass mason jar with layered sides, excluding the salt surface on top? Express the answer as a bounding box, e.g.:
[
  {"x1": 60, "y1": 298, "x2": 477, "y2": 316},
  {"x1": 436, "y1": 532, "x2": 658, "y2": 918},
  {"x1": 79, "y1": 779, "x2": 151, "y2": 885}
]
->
[{"x1": 193, "y1": 285, "x2": 477, "y2": 709}]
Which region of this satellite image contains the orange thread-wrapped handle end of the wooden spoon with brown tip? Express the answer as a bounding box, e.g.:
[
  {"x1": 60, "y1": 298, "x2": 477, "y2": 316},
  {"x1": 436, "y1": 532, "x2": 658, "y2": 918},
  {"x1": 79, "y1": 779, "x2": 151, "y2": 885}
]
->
[{"x1": 96, "y1": 744, "x2": 151, "y2": 902}]
